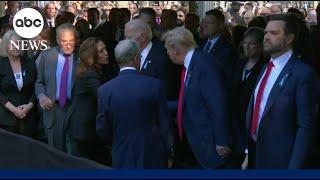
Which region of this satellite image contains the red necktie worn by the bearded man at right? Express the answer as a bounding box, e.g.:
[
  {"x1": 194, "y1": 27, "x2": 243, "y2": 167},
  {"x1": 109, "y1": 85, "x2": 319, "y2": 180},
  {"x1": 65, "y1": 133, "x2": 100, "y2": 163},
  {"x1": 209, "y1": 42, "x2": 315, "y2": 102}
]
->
[{"x1": 251, "y1": 62, "x2": 274, "y2": 137}]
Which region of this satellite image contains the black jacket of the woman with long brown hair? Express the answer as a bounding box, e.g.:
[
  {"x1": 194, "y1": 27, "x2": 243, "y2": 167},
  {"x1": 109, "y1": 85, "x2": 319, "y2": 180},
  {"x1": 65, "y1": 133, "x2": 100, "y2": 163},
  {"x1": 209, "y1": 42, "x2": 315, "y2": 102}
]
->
[{"x1": 64, "y1": 70, "x2": 102, "y2": 142}]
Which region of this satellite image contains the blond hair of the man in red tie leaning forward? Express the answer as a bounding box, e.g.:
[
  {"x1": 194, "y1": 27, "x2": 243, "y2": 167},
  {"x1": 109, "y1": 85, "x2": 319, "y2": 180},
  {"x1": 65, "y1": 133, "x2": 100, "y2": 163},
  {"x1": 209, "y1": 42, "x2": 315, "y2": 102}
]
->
[{"x1": 162, "y1": 27, "x2": 197, "y2": 50}]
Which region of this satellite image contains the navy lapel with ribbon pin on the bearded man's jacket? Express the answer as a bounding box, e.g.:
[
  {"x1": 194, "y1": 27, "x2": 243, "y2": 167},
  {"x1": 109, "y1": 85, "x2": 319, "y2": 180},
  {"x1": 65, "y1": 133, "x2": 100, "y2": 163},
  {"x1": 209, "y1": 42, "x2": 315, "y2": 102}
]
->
[{"x1": 261, "y1": 55, "x2": 294, "y2": 120}]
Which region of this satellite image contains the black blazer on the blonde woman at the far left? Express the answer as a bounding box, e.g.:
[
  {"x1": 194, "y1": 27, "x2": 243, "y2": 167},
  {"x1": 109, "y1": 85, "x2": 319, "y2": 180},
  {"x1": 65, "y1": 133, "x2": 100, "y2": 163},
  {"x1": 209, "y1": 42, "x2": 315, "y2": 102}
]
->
[{"x1": 0, "y1": 56, "x2": 37, "y2": 126}]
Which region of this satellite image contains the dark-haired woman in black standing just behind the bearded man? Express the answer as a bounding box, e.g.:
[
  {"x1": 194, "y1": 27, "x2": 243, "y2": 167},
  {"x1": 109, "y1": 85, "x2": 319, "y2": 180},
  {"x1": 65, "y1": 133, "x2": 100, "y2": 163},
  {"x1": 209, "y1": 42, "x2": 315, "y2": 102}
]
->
[{"x1": 233, "y1": 27, "x2": 267, "y2": 167}]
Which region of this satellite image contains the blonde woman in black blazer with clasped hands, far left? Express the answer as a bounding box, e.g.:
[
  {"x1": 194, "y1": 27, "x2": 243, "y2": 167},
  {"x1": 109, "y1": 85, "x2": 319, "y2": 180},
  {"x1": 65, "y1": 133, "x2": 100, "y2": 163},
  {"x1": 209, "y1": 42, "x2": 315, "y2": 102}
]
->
[{"x1": 0, "y1": 31, "x2": 36, "y2": 137}]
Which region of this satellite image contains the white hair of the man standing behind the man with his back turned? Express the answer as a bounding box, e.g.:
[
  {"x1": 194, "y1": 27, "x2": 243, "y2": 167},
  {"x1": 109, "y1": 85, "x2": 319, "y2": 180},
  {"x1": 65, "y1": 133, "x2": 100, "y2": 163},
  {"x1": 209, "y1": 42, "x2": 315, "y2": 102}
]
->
[{"x1": 125, "y1": 19, "x2": 152, "y2": 41}]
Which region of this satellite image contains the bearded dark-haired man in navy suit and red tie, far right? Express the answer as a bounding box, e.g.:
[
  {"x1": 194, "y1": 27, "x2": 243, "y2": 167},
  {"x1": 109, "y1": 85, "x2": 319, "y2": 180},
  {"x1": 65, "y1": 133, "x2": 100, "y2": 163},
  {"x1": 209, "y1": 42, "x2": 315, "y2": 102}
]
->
[{"x1": 246, "y1": 15, "x2": 319, "y2": 169}]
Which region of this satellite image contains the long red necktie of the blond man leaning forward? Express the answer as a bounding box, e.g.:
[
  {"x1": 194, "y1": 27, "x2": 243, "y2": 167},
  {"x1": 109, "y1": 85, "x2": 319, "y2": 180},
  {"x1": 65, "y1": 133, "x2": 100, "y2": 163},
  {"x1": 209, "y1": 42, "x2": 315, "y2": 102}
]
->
[{"x1": 177, "y1": 67, "x2": 186, "y2": 140}]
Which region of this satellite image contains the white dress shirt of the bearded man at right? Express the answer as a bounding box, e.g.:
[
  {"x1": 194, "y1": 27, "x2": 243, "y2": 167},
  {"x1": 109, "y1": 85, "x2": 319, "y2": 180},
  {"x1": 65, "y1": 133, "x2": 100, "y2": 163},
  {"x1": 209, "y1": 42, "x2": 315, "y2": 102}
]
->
[{"x1": 253, "y1": 50, "x2": 292, "y2": 139}]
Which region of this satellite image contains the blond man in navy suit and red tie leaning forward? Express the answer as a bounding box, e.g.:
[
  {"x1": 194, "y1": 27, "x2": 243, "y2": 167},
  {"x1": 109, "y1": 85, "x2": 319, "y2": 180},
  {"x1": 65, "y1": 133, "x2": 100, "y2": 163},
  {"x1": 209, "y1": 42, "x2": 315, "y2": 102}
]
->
[{"x1": 163, "y1": 27, "x2": 232, "y2": 168}]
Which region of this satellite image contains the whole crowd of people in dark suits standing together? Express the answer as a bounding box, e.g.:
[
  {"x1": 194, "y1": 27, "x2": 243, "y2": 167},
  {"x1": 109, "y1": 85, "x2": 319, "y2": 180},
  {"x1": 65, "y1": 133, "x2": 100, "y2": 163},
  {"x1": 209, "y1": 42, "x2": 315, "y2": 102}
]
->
[{"x1": 0, "y1": 0, "x2": 320, "y2": 169}]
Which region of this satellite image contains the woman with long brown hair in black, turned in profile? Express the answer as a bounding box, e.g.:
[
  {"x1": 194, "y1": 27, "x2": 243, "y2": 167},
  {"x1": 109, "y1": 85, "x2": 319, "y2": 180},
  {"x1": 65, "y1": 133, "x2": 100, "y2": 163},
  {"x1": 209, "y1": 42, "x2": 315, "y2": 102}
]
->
[{"x1": 65, "y1": 37, "x2": 109, "y2": 163}]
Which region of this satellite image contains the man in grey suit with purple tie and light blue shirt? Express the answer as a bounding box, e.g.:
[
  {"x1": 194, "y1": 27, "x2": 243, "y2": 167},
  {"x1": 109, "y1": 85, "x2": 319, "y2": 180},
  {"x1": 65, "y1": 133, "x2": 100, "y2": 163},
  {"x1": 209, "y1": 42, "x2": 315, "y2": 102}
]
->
[{"x1": 35, "y1": 23, "x2": 78, "y2": 151}]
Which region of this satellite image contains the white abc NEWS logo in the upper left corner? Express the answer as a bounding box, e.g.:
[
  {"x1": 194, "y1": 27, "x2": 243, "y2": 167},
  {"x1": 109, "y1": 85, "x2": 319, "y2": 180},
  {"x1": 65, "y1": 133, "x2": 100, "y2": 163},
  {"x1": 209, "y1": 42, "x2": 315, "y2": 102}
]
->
[{"x1": 10, "y1": 8, "x2": 48, "y2": 50}]
